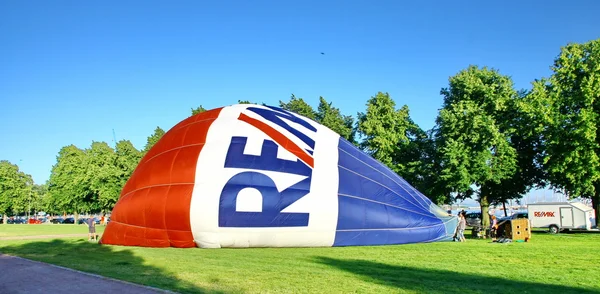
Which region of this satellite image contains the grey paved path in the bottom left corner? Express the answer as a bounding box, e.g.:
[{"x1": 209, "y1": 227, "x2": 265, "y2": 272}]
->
[{"x1": 0, "y1": 253, "x2": 173, "y2": 294}]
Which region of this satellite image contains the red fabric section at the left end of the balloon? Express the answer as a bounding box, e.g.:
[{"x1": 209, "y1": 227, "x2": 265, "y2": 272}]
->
[{"x1": 100, "y1": 108, "x2": 221, "y2": 248}]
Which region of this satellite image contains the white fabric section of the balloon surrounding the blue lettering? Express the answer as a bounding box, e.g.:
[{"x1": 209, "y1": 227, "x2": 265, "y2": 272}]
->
[{"x1": 190, "y1": 104, "x2": 339, "y2": 248}]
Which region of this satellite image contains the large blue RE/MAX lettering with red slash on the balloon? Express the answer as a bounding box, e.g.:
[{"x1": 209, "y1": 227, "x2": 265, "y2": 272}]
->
[{"x1": 219, "y1": 107, "x2": 316, "y2": 227}]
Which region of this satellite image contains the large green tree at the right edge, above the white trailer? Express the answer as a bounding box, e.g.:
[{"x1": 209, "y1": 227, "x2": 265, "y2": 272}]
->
[{"x1": 535, "y1": 39, "x2": 600, "y2": 223}]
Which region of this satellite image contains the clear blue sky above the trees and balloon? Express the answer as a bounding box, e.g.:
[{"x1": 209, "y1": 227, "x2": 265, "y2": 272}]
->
[{"x1": 0, "y1": 0, "x2": 600, "y2": 189}]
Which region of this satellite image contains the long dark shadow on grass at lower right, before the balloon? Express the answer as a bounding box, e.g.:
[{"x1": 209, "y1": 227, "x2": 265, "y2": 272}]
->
[{"x1": 316, "y1": 256, "x2": 598, "y2": 294}]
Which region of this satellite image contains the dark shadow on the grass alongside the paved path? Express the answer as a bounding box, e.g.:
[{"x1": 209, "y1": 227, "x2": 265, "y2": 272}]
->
[{"x1": 0, "y1": 239, "x2": 225, "y2": 293}]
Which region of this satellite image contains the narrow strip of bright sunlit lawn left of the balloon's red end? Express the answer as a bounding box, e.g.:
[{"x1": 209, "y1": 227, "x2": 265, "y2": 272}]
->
[{"x1": 0, "y1": 224, "x2": 104, "y2": 238}]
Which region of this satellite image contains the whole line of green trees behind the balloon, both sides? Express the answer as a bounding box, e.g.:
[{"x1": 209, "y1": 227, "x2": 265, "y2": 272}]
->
[{"x1": 0, "y1": 39, "x2": 600, "y2": 225}]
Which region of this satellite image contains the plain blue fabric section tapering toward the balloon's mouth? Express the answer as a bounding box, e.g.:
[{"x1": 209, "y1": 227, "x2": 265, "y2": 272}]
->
[{"x1": 333, "y1": 138, "x2": 449, "y2": 246}]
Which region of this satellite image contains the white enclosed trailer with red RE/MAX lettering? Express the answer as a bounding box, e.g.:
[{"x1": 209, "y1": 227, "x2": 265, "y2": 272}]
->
[{"x1": 527, "y1": 202, "x2": 596, "y2": 234}]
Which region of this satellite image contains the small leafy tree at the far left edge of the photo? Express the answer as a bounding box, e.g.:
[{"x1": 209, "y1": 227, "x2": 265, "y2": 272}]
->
[{"x1": 0, "y1": 160, "x2": 33, "y2": 224}]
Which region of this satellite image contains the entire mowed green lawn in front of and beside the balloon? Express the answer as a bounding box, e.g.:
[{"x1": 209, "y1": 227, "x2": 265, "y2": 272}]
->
[{"x1": 0, "y1": 225, "x2": 600, "y2": 293}]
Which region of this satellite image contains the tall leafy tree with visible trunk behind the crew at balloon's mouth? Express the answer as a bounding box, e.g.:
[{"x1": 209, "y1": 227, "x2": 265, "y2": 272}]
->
[{"x1": 436, "y1": 66, "x2": 517, "y2": 226}]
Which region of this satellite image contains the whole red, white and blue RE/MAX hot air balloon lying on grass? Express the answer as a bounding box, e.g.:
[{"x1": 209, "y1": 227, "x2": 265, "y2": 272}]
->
[{"x1": 101, "y1": 104, "x2": 457, "y2": 248}]
